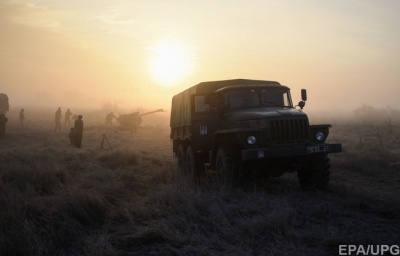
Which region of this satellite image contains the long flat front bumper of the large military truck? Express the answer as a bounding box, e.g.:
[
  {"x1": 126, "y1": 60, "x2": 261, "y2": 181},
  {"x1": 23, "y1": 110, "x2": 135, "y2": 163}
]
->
[{"x1": 242, "y1": 143, "x2": 342, "y2": 161}]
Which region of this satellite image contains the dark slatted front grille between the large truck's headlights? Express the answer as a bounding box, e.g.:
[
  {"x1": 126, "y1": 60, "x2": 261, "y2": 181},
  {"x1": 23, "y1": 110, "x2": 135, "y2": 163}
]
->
[{"x1": 271, "y1": 118, "x2": 308, "y2": 143}]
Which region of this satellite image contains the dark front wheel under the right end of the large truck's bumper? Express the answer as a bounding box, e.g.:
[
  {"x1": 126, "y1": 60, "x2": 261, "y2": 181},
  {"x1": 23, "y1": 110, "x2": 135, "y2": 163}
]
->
[{"x1": 297, "y1": 154, "x2": 330, "y2": 190}]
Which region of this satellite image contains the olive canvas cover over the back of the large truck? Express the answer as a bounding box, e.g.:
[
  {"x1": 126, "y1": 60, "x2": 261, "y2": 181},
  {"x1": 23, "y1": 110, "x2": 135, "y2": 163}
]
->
[{"x1": 170, "y1": 79, "x2": 280, "y2": 128}]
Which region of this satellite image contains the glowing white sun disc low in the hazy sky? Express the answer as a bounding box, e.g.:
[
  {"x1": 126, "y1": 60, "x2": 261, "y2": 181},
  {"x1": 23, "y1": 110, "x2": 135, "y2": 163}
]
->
[{"x1": 149, "y1": 41, "x2": 191, "y2": 86}]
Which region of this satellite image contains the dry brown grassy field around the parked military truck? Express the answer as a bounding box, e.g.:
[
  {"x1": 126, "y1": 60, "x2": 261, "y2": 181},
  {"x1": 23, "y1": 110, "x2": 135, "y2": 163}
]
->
[{"x1": 0, "y1": 110, "x2": 400, "y2": 255}]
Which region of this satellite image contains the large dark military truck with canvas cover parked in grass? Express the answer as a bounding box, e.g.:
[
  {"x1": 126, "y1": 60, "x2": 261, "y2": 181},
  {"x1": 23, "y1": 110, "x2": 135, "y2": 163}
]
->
[{"x1": 170, "y1": 79, "x2": 341, "y2": 189}]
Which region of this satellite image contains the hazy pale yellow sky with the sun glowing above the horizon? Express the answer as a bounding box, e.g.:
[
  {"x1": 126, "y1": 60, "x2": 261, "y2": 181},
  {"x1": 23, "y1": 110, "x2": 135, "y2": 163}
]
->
[{"x1": 0, "y1": 0, "x2": 400, "y2": 110}]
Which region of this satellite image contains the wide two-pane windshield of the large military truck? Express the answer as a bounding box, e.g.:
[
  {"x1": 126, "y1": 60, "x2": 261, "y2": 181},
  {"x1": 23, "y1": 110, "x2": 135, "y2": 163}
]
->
[{"x1": 224, "y1": 88, "x2": 292, "y2": 109}]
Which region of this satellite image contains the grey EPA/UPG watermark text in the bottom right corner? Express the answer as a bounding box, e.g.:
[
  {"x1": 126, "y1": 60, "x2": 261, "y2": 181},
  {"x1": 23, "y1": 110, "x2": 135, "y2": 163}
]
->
[{"x1": 339, "y1": 244, "x2": 400, "y2": 255}]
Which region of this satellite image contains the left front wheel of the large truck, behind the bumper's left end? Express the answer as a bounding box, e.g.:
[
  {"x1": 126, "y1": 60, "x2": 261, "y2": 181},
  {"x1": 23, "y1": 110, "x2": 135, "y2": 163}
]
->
[{"x1": 215, "y1": 147, "x2": 239, "y2": 185}]
